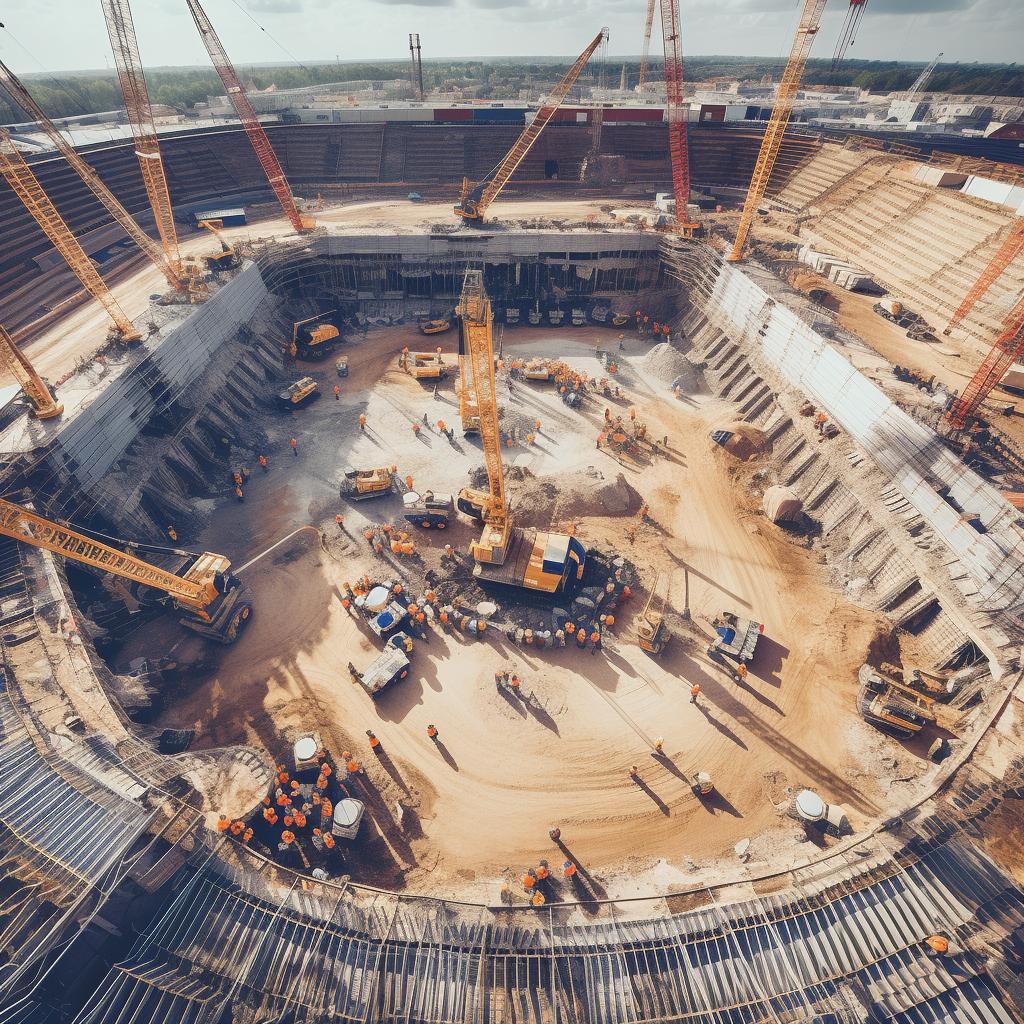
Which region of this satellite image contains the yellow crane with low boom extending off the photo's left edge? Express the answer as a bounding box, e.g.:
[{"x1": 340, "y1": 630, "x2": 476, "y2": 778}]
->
[{"x1": 0, "y1": 499, "x2": 253, "y2": 644}]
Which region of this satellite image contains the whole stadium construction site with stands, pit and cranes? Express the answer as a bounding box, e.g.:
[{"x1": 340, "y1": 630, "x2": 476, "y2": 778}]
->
[{"x1": 0, "y1": 0, "x2": 1024, "y2": 1024}]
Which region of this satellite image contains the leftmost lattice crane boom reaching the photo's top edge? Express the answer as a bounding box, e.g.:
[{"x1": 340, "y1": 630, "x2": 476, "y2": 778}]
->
[{"x1": 100, "y1": 0, "x2": 181, "y2": 278}]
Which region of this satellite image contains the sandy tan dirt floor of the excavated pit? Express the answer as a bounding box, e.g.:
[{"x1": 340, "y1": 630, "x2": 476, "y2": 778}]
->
[{"x1": 105, "y1": 317, "x2": 897, "y2": 900}]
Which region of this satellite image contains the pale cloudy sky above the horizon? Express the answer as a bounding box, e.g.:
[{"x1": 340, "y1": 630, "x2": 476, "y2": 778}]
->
[{"x1": 0, "y1": 0, "x2": 1024, "y2": 74}]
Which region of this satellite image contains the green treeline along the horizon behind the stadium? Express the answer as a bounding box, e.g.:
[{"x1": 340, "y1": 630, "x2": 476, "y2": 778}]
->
[{"x1": 0, "y1": 56, "x2": 1024, "y2": 124}]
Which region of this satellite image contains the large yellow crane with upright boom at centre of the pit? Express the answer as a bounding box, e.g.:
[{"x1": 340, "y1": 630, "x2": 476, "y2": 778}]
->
[{"x1": 458, "y1": 270, "x2": 587, "y2": 594}]
